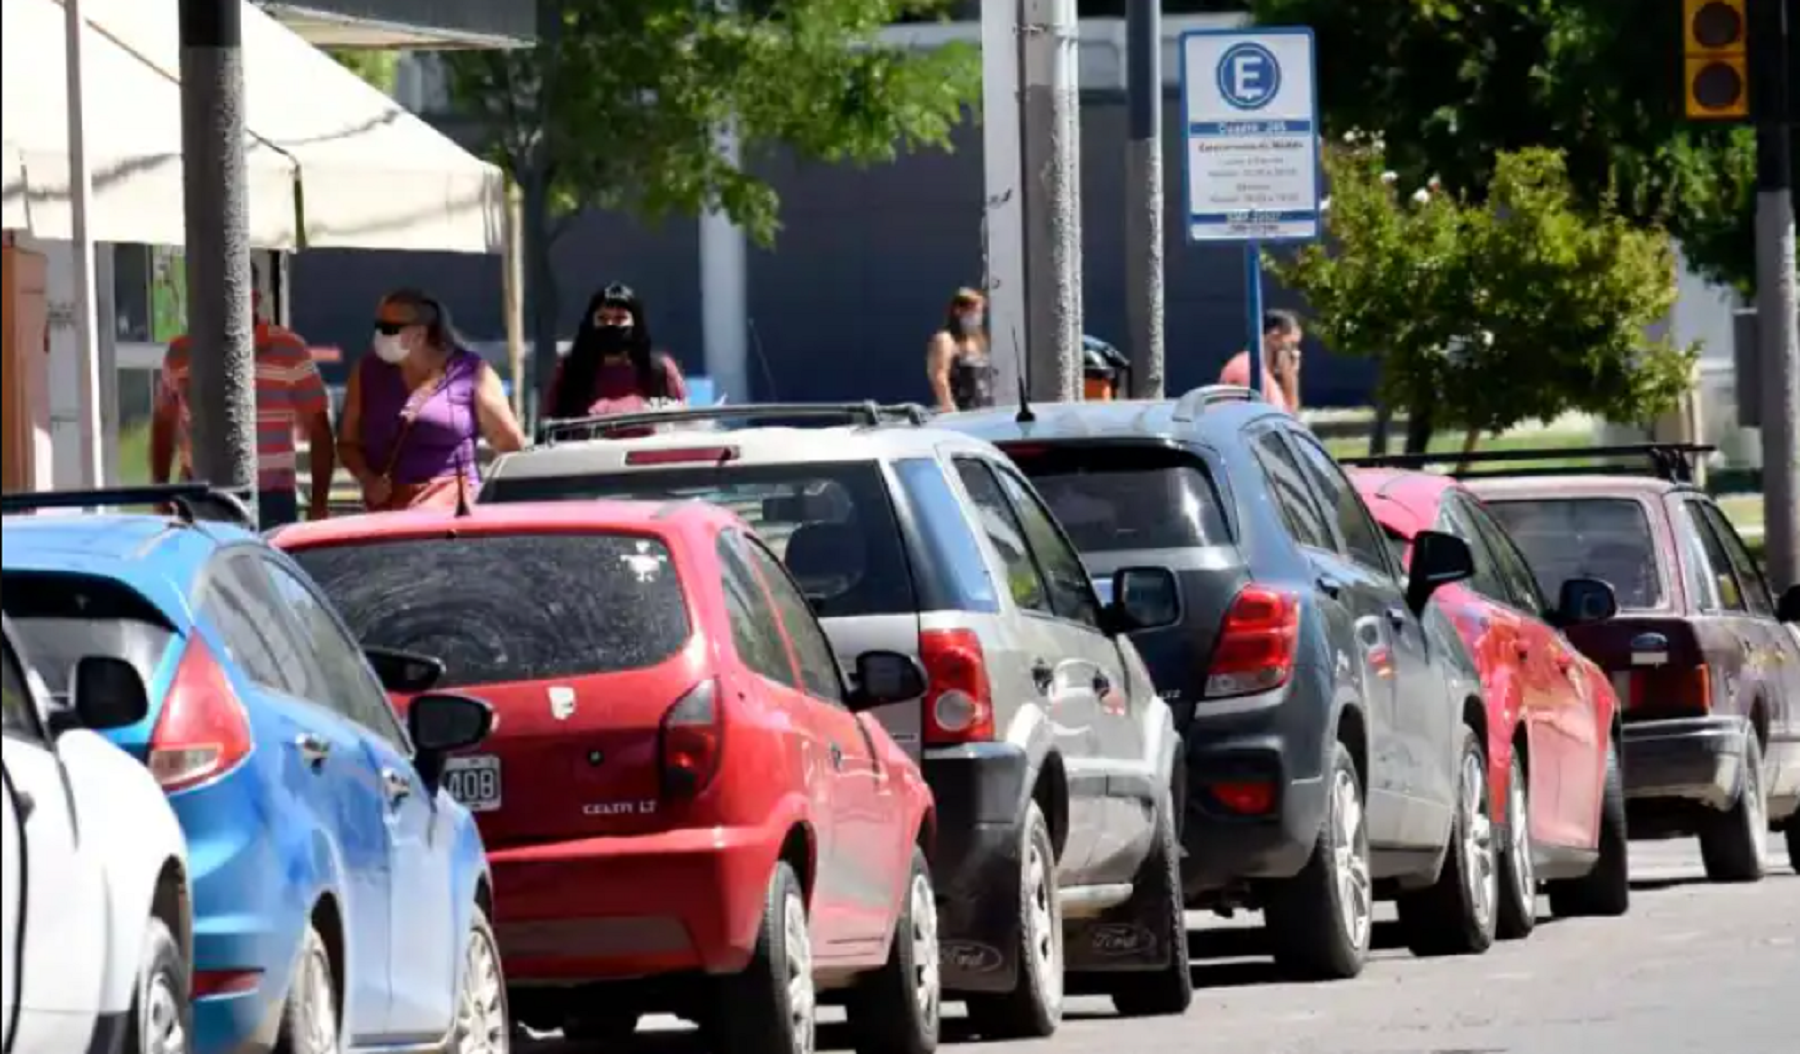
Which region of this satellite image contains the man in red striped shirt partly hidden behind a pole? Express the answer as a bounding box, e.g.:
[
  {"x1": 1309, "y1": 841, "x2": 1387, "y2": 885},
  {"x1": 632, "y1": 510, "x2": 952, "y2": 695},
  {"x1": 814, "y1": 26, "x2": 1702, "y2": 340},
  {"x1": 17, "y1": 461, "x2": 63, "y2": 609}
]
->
[{"x1": 149, "y1": 287, "x2": 337, "y2": 531}]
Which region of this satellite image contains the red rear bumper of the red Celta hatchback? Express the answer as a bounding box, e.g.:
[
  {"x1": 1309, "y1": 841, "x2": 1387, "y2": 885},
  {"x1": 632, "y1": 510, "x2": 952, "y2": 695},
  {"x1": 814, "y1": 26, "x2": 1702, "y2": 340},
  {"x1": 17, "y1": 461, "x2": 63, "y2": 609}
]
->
[{"x1": 488, "y1": 827, "x2": 781, "y2": 984}]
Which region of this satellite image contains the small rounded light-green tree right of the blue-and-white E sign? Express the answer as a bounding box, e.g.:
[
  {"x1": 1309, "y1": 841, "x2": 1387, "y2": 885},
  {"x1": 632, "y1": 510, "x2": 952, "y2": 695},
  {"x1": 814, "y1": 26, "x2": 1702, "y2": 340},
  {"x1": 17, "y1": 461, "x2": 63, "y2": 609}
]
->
[{"x1": 1273, "y1": 144, "x2": 1697, "y2": 432}]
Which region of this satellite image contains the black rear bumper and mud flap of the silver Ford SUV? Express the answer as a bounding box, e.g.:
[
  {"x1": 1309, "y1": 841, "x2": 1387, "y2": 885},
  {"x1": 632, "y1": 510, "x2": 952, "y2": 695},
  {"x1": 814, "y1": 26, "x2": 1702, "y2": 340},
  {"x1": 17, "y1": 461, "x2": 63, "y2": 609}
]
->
[{"x1": 920, "y1": 743, "x2": 1031, "y2": 991}]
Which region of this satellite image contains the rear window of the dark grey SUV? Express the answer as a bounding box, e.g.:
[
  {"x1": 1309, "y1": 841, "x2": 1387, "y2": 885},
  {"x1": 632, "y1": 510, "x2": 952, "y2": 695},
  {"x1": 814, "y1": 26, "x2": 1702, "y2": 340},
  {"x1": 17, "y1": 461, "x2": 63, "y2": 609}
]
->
[{"x1": 1001, "y1": 444, "x2": 1231, "y2": 552}]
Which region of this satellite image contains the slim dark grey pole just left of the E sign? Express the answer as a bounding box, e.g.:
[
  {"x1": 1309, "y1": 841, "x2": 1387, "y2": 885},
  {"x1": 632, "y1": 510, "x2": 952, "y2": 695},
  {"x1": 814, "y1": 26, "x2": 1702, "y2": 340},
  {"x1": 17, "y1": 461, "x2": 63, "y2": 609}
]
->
[{"x1": 1125, "y1": 0, "x2": 1163, "y2": 399}]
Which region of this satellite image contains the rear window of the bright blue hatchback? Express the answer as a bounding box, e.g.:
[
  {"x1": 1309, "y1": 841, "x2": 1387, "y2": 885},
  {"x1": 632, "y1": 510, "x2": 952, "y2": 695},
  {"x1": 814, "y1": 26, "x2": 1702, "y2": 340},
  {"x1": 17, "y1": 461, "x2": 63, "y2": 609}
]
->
[{"x1": 0, "y1": 570, "x2": 175, "y2": 698}]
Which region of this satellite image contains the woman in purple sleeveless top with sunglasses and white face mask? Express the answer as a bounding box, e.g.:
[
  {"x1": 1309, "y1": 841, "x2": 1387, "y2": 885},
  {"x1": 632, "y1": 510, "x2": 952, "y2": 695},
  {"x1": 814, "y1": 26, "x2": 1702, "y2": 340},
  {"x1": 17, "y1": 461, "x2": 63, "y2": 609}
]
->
[{"x1": 338, "y1": 290, "x2": 526, "y2": 513}]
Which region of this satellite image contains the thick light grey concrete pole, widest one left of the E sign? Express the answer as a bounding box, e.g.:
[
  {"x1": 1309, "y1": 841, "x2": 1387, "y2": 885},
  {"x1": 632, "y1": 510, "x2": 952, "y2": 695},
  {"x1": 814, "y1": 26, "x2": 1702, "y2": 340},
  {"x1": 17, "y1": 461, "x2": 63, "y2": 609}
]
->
[{"x1": 1019, "y1": 0, "x2": 1082, "y2": 403}]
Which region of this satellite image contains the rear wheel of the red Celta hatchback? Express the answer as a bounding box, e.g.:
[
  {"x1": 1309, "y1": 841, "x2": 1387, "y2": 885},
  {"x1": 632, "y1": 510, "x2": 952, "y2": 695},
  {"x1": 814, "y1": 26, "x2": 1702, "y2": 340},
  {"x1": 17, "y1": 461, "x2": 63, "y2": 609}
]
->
[{"x1": 707, "y1": 862, "x2": 817, "y2": 1054}]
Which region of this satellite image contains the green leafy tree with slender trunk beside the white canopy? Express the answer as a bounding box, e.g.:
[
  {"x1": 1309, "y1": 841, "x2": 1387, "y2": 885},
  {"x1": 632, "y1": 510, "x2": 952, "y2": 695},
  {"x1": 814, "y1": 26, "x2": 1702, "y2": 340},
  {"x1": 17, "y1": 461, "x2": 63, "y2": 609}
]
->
[{"x1": 446, "y1": 0, "x2": 981, "y2": 408}]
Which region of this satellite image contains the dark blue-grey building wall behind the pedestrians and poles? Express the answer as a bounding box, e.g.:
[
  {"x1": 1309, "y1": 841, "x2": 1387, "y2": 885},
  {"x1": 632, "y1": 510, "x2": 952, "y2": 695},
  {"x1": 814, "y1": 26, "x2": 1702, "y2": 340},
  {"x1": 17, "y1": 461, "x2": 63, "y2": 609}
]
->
[{"x1": 293, "y1": 94, "x2": 1372, "y2": 405}]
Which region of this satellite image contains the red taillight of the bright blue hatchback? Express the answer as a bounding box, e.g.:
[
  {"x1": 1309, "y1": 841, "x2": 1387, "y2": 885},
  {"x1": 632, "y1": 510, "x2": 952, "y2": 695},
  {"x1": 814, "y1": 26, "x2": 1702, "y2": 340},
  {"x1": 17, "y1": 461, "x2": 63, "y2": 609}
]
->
[{"x1": 149, "y1": 637, "x2": 250, "y2": 793}]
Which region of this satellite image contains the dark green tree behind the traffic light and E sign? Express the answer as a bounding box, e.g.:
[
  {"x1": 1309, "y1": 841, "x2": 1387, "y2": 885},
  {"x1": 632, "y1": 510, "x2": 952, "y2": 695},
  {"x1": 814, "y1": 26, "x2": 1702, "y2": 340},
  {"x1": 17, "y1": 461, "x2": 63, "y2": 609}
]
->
[{"x1": 1251, "y1": 0, "x2": 1755, "y2": 293}]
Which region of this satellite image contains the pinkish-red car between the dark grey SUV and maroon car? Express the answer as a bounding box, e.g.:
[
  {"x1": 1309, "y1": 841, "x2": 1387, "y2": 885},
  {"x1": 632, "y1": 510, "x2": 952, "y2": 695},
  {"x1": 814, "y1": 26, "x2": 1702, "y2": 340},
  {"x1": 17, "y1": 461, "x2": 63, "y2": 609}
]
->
[{"x1": 1350, "y1": 469, "x2": 1631, "y2": 939}]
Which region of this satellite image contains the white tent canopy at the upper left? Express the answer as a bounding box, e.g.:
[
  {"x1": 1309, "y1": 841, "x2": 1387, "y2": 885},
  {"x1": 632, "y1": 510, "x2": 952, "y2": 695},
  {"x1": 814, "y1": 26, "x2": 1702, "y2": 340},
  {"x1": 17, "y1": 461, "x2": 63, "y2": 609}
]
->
[{"x1": 0, "y1": 0, "x2": 506, "y2": 252}]
